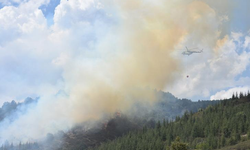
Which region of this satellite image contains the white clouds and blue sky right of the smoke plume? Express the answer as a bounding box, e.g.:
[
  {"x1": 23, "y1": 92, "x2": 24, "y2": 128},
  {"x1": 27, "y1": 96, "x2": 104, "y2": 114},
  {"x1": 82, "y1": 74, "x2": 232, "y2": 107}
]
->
[{"x1": 166, "y1": 0, "x2": 250, "y2": 100}]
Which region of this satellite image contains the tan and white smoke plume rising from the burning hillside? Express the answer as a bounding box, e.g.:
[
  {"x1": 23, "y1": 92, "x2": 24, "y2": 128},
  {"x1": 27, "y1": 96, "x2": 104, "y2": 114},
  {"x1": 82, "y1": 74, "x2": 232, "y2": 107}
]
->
[{"x1": 0, "y1": 0, "x2": 230, "y2": 143}]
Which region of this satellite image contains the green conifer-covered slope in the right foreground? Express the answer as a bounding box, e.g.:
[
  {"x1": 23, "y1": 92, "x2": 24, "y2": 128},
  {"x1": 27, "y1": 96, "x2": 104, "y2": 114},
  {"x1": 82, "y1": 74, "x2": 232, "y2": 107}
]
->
[{"x1": 91, "y1": 93, "x2": 250, "y2": 150}]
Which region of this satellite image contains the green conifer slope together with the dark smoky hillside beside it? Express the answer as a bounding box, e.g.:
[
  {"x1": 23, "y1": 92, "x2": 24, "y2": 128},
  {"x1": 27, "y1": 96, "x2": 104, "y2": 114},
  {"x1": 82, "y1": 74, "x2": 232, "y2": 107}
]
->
[{"x1": 0, "y1": 93, "x2": 250, "y2": 150}]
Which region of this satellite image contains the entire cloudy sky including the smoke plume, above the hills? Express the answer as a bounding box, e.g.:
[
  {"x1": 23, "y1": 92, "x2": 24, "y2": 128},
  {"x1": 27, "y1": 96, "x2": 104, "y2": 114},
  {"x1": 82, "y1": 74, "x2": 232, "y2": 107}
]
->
[{"x1": 0, "y1": 0, "x2": 250, "y2": 143}]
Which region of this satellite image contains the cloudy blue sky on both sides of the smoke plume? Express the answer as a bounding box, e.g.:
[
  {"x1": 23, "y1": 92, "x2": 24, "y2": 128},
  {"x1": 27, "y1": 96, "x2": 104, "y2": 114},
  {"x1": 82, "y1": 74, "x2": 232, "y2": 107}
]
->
[{"x1": 0, "y1": 0, "x2": 250, "y2": 103}]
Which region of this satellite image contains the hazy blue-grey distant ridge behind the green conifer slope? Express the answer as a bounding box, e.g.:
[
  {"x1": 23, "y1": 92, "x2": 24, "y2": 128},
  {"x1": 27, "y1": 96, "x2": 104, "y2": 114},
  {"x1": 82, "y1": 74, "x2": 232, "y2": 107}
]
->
[{"x1": 126, "y1": 91, "x2": 219, "y2": 121}]
